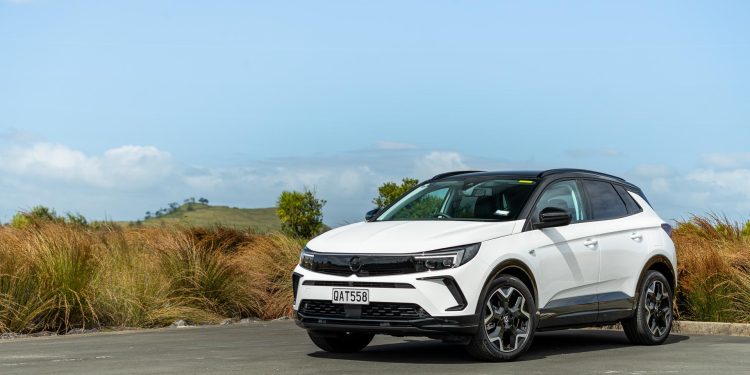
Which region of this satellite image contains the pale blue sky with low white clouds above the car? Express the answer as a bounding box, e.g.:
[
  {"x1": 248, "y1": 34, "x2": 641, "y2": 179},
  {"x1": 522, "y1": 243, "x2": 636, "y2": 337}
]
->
[{"x1": 0, "y1": 0, "x2": 750, "y2": 226}]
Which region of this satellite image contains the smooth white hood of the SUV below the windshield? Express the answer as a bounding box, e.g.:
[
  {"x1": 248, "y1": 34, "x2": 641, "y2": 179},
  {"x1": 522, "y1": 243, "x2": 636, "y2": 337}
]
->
[{"x1": 307, "y1": 220, "x2": 522, "y2": 254}]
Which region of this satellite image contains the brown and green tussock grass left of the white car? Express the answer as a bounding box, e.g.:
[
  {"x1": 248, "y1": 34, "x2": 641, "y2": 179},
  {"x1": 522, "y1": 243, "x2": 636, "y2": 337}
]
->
[{"x1": 0, "y1": 223, "x2": 302, "y2": 332}]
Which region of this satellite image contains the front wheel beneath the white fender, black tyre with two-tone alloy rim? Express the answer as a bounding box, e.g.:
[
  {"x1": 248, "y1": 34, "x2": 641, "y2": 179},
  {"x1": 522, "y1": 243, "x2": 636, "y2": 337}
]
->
[{"x1": 466, "y1": 275, "x2": 537, "y2": 362}]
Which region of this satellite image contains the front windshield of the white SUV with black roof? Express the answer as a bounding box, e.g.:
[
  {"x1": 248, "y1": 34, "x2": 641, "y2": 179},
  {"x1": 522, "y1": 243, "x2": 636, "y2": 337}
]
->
[{"x1": 376, "y1": 178, "x2": 537, "y2": 221}]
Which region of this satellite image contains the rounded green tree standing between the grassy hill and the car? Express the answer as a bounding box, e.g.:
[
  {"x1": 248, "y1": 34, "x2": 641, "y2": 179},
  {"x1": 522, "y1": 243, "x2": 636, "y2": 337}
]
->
[{"x1": 276, "y1": 188, "x2": 326, "y2": 238}]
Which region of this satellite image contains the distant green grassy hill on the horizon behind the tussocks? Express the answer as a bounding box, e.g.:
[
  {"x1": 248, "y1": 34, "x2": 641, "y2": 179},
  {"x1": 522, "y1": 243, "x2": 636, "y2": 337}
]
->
[{"x1": 143, "y1": 203, "x2": 281, "y2": 232}]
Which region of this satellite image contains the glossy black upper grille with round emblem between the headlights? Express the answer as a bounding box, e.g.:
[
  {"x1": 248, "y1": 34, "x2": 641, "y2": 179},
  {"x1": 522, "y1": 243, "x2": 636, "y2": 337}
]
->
[{"x1": 310, "y1": 253, "x2": 425, "y2": 276}]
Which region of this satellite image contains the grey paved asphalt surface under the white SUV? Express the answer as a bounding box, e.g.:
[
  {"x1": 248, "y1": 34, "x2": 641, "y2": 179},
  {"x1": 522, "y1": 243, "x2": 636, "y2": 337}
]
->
[{"x1": 0, "y1": 321, "x2": 750, "y2": 375}]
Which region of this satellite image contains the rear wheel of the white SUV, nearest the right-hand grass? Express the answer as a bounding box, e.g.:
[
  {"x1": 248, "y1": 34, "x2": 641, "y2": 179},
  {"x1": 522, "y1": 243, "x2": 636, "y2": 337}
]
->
[{"x1": 622, "y1": 271, "x2": 674, "y2": 345}]
